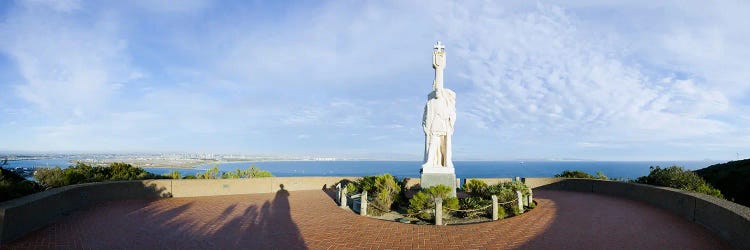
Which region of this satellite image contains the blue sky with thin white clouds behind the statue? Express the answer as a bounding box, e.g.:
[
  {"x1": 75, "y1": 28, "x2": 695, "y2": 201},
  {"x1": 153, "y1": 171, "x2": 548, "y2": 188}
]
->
[{"x1": 0, "y1": 0, "x2": 750, "y2": 160}]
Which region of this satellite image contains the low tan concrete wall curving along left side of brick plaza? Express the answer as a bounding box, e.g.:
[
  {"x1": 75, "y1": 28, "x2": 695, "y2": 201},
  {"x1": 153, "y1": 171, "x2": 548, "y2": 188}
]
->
[{"x1": 0, "y1": 177, "x2": 360, "y2": 244}]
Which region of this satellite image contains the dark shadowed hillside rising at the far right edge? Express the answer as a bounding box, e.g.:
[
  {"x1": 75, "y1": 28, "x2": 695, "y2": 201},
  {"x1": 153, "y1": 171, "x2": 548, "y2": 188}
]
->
[{"x1": 695, "y1": 159, "x2": 750, "y2": 207}]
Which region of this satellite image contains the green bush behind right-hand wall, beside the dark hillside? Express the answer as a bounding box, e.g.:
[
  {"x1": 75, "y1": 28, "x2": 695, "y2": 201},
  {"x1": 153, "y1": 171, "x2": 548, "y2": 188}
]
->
[{"x1": 635, "y1": 166, "x2": 724, "y2": 198}]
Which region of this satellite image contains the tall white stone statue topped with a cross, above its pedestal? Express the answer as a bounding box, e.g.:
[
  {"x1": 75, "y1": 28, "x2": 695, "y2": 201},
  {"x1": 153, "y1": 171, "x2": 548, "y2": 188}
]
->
[{"x1": 422, "y1": 41, "x2": 456, "y2": 170}]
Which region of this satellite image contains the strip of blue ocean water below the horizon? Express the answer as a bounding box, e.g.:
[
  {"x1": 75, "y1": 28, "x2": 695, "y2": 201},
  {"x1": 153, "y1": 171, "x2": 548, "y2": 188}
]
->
[{"x1": 8, "y1": 159, "x2": 720, "y2": 179}]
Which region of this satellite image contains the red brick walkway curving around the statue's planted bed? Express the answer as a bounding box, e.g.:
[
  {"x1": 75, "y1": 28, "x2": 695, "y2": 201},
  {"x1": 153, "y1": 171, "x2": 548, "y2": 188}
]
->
[{"x1": 2, "y1": 190, "x2": 730, "y2": 249}]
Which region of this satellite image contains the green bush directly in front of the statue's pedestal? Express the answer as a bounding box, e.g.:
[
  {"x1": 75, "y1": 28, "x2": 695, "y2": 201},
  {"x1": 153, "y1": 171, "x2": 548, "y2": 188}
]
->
[{"x1": 407, "y1": 185, "x2": 458, "y2": 220}]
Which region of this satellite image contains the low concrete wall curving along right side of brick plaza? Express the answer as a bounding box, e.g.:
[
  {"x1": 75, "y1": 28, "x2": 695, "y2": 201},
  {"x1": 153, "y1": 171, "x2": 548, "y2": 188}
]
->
[{"x1": 524, "y1": 178, "x2": 750, "y2": 249}]
